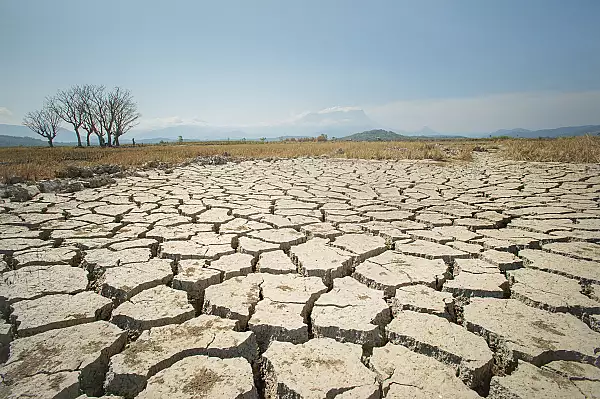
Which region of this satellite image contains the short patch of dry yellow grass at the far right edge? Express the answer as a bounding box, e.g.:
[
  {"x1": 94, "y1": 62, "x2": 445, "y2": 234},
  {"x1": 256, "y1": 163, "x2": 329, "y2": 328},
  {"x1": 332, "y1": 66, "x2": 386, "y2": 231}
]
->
[{"x1": 501, "y1": 135, "x2": 600, "y2": 163}]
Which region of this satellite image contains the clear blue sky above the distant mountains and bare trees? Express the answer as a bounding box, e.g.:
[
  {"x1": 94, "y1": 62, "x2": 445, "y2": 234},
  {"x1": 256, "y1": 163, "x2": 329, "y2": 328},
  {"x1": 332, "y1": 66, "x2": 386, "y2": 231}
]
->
[{"x1": 0, "y1": 0, "x2": 600, "y2": 132}]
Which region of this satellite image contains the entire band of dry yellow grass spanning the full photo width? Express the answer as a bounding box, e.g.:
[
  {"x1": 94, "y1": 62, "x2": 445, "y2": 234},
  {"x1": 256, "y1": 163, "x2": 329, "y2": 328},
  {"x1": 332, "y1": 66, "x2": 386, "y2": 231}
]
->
[{"x1": 0, "y1": 136, "x2": 600, "y2": 181}]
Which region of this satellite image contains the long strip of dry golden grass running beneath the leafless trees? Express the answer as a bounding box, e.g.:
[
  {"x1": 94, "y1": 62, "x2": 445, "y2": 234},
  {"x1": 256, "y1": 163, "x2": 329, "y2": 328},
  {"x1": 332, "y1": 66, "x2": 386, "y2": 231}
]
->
[{"x1": 0, "y1": 140, "x2": 472, "y2": 181}]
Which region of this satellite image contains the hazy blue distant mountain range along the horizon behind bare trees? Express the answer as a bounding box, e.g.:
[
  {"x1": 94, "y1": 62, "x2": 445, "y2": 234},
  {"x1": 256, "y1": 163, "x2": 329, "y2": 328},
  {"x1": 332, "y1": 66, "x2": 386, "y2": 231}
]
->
[{"x1": 0, "y1": 117, "x2": 600, "y2": 147}]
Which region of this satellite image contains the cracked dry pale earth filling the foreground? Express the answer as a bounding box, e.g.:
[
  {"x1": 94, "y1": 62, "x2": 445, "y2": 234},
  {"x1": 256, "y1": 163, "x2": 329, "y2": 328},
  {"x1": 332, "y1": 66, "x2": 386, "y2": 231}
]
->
[{"x1": 0, "y1": 154, "x2": 600, "y2": 399}]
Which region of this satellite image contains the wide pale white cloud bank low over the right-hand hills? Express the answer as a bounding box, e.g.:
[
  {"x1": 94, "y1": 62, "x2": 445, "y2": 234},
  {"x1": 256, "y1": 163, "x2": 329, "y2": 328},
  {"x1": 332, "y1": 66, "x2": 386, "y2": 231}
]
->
[{"x1": 365, "y1": 91, "x2": 600, "y2": 133}]
